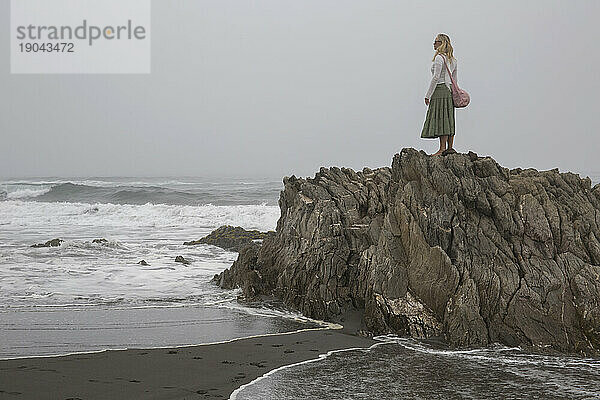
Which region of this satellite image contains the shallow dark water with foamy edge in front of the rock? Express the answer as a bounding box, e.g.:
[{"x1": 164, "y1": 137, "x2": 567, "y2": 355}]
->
[{"x1": 235, "y1": 338, "x2": 600, "y2": 400}]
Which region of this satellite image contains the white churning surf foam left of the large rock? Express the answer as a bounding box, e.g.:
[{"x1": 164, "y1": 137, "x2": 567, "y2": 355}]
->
[{"x1": 0, "y1": 200, "x2": 279, "y2": 312}]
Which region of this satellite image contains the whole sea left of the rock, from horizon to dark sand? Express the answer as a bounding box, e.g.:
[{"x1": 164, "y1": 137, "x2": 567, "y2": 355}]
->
[{"x1": 0, "y1": 178, "x2": 328, "y2": 358}]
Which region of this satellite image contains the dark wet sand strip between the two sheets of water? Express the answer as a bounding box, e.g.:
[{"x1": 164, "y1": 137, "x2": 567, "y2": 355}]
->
[{"x1": 0, "y1": 330, "x2": 374, "y2": 400}]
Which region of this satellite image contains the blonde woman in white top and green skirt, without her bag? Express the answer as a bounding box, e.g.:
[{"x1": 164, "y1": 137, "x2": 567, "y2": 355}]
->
[{"x1": 421, "y1": 33, "x2": 457, "y2": 156}]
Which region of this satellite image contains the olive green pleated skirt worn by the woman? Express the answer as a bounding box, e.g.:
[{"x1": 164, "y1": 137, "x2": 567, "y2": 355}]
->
[{"x1": 421, "y1": 83, "x2": 454, "y2": 139}]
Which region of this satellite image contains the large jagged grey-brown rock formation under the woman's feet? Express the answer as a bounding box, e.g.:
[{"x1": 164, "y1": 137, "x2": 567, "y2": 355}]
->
[{"x1": 217, "y1": 149, "x2": 600, "y2": 353}]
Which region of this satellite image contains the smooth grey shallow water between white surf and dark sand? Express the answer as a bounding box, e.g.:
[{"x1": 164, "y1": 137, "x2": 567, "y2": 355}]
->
[{"x1": 0, "y1": 303, "x2": 320, "y2": 359}]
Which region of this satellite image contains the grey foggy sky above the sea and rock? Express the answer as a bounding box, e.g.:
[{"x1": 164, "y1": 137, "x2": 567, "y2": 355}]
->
[{"x1": 0, "y1": 0, "x2": 600, "y2": 177}]
